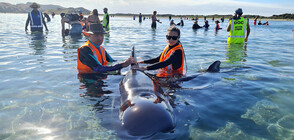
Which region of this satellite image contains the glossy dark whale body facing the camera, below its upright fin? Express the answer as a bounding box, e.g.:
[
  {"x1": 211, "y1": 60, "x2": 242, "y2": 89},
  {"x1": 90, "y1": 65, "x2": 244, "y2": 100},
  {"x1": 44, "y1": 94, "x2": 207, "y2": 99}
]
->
[{"x1": 119, "y1": 70, "x2": 175, "y2": 136}]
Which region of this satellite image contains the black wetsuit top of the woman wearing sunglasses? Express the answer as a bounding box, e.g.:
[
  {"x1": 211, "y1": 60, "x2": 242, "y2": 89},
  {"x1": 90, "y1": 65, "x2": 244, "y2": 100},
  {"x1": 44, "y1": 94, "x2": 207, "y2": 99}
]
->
[{"x1": 144, "y1": 43, "x2": 184, "y2": 70}]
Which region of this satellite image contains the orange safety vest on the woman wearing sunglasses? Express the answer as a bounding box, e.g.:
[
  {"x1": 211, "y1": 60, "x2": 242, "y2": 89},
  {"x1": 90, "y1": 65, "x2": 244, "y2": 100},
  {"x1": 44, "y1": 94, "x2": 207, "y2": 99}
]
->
[{"x1": 156, "y1": 44, "x2": 185, "y2": 77}]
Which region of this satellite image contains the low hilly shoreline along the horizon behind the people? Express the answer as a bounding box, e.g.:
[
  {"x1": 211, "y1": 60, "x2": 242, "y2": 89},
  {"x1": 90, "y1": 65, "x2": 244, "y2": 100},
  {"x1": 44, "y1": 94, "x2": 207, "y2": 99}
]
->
[{"x1": 0, "y1": 2, "x2": 294, "y2": 21}]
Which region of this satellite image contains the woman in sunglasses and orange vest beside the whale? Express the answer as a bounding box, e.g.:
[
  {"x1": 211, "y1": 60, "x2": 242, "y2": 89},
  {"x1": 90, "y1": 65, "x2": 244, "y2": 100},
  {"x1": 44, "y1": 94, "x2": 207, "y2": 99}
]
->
[{"x1": 137, "y1": 26, "x2": 185, "y2": 77}]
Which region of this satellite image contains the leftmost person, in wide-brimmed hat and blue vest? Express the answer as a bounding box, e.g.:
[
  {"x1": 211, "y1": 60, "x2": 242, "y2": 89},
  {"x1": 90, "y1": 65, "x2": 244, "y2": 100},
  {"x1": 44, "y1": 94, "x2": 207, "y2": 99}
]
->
[{"x1": 25, "y1": 2, "x2": 48, "y2": 32}]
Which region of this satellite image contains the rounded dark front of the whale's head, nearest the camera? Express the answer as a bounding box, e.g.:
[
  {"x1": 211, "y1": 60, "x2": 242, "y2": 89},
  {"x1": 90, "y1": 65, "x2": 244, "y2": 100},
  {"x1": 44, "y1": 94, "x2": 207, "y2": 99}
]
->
[{"x1": 121, "y1": 100, "x2": 175, "y2": 136}]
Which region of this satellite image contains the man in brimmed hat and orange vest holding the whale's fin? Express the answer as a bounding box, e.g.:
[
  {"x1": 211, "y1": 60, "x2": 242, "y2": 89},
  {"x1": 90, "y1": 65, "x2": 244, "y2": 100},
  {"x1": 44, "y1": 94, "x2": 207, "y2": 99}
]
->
[{"x1": 77, "y1": 23, "x2": 136, "y2": 74}]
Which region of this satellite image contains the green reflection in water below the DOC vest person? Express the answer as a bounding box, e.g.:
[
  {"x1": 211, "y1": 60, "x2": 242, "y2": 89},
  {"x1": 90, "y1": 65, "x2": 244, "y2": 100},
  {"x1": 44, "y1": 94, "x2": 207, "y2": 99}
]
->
[{"x1": 226, "y1": 44, "x2": 247, "y2": 64}]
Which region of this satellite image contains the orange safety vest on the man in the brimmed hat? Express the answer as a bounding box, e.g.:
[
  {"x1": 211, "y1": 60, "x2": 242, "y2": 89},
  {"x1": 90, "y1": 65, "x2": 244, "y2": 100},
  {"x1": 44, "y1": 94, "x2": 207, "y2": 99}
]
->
[{"x1": 77, "y1": 41, "x2": 108, "y2": 73}]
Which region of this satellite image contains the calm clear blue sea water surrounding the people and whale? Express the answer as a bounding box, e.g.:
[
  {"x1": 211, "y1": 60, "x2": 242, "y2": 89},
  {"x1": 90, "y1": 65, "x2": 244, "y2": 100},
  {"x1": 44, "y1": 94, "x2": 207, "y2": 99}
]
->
[{"x1": 0, "y1": 14, "x2": 294, "y2": 140}]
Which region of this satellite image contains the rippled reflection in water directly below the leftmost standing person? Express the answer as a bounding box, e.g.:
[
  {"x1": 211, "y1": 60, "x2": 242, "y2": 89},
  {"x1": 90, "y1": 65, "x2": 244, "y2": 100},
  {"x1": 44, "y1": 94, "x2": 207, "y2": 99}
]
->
[{"x1": 26, "y1": 32, "x2": 48, "y2": 55}]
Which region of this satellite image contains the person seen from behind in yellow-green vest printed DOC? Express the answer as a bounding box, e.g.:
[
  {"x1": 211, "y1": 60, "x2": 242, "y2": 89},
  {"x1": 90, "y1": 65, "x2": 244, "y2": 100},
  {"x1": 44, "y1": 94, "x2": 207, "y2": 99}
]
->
[{"x1": 227, "y1": 8, "x2": 250, "y2": 44}]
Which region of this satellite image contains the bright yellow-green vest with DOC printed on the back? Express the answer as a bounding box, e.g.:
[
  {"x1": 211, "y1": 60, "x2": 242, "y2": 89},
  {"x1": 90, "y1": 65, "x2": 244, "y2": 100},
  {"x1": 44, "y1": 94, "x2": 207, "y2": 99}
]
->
[{"x1": 227, "y1": 17, "x2": 247, "y2": 44}]
